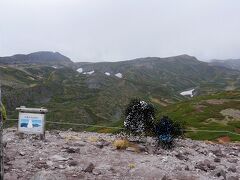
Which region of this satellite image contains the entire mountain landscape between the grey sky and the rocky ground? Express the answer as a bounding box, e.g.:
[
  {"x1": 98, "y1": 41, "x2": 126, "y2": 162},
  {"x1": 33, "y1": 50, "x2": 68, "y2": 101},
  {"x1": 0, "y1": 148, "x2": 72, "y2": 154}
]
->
[{"x1": 0, "y1": 51, "x2": 240, "y2": 140}]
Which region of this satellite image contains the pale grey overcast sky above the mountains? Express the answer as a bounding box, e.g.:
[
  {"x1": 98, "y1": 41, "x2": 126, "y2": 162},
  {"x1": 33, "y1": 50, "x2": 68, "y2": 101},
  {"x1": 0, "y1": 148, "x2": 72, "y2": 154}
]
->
[{"x1": 0, "y1": 0, "x2": 240, "y2": 61}]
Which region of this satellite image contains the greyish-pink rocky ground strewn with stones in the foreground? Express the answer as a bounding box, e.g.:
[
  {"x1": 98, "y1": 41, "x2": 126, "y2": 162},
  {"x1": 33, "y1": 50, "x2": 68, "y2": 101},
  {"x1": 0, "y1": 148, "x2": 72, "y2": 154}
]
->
[{"x1": 1, "y1": 129, "x2": 240, "y2": 180}]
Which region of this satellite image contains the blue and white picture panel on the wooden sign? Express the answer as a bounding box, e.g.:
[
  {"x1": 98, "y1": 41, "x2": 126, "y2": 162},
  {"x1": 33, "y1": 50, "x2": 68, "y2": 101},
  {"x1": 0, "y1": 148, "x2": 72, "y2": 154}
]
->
[{"x1": 18, "y1": 112, "x2": 44, "y2": 134}]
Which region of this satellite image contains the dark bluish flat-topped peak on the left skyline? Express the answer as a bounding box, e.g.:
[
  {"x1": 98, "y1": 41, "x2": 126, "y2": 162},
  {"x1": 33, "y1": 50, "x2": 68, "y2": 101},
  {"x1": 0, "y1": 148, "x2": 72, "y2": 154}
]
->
[{"x1": 0, "y1": 51, "x2": 73, "y2": 66}]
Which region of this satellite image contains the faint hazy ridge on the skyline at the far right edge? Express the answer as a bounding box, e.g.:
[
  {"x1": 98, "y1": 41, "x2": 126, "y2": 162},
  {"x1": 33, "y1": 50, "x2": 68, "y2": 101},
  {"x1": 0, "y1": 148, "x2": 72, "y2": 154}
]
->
[{"x1": 210, "y1": 59, "x2": 240, "y2": 70}]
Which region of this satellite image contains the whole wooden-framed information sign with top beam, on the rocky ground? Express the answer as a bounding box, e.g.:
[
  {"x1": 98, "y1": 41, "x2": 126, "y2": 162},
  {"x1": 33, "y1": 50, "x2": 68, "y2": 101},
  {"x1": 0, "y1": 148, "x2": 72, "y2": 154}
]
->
[{"x1": 16, "y1": 106, "x2": 48, "y2": 140}]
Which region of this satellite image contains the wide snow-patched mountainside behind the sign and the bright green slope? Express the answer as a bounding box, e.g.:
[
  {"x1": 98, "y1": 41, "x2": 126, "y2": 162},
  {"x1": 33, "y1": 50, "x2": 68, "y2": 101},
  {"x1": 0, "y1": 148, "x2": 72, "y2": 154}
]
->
[{"x1": 0, "y1": 52, "x2": 240, "y2": 129}]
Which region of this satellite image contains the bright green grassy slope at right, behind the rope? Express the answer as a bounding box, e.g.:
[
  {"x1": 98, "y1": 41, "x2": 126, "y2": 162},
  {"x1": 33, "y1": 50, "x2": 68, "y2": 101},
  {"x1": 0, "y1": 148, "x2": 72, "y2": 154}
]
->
[{"x1": 158, "y1": 91, "x2": 240, "y2": 140}]
